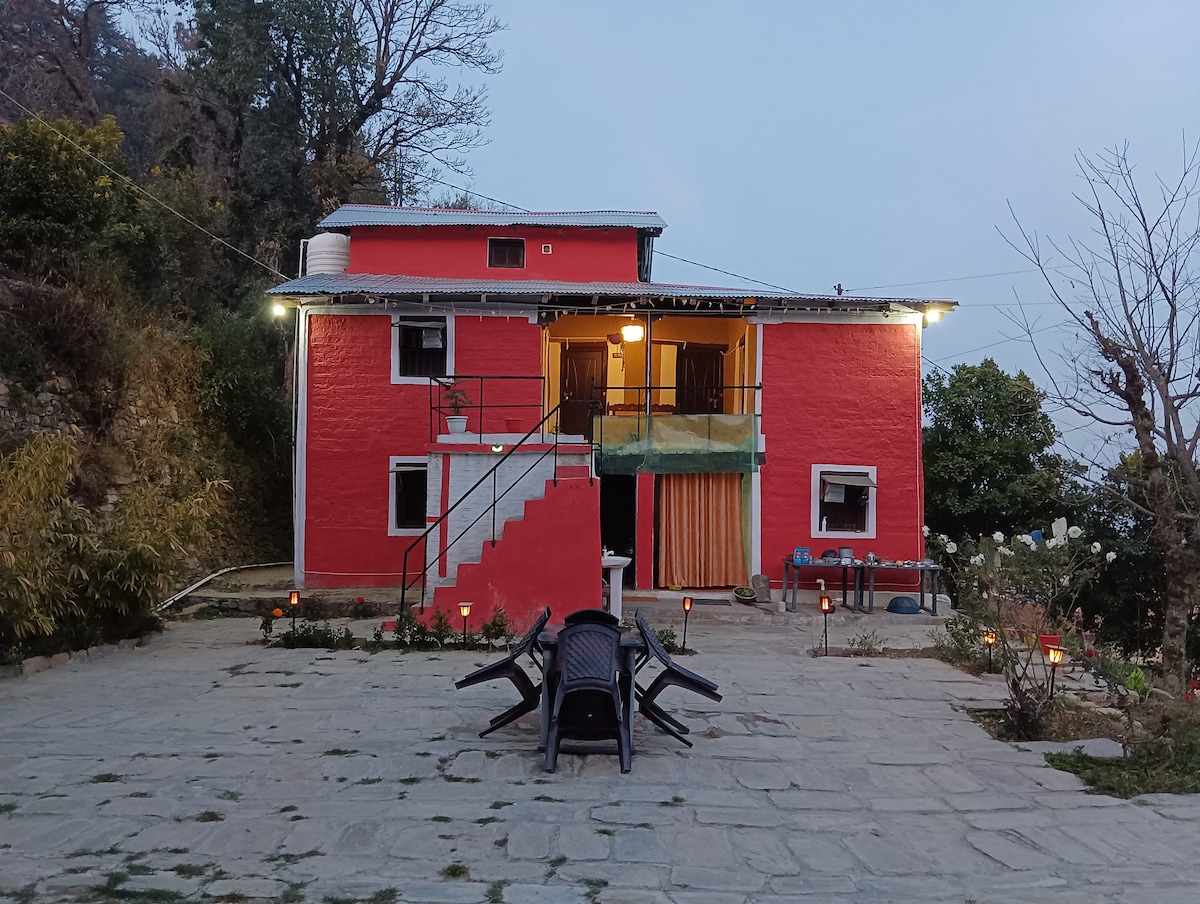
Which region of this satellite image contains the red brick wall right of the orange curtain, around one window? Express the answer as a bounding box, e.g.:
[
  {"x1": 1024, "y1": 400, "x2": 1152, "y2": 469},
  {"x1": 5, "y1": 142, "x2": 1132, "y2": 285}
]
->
[{"x1": 761, "y1": 323, "x2": 924, "y2": 587}]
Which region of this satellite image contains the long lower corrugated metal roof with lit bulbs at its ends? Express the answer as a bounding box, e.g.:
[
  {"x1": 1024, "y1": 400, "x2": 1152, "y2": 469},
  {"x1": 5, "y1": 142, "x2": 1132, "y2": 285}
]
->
[{"x1": 268, "y1": 273, "x2": 956, "y2": 309}]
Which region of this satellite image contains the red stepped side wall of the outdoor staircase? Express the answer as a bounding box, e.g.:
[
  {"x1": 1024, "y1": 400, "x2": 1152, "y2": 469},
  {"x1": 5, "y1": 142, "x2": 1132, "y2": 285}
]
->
[{"x1": 424, "y1": 477, "x2": 602, "y2": 633}]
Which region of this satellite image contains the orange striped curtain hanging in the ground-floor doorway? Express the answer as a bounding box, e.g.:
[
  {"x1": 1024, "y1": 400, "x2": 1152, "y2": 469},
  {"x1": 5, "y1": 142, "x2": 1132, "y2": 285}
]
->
[{"x1": 659, "y1": 474, "x2": 746, "y2": 587}]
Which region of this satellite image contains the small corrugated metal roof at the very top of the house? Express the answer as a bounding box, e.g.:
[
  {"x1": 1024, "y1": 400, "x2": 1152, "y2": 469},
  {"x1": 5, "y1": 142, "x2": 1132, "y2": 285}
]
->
[{"x1": 320, "y1": 204, "x2": 666, "y2": 229}]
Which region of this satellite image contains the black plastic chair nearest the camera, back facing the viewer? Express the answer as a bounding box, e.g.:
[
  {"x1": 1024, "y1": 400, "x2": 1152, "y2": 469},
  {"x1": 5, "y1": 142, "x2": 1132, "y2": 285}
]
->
[{"x1": 546, "y1": 622, "x2": 634, "y2": 772}]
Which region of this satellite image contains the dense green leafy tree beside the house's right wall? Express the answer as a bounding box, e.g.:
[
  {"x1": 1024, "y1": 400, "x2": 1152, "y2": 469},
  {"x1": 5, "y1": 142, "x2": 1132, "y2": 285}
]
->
[{"x1": 923, "y1": 358, "x2": 1073, "y2": 538}]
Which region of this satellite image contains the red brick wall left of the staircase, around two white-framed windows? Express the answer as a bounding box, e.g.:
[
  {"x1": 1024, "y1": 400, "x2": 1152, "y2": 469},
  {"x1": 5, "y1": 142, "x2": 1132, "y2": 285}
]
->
[{"x1": 304, "y1": 313, "x2": 541, "y2": 587}]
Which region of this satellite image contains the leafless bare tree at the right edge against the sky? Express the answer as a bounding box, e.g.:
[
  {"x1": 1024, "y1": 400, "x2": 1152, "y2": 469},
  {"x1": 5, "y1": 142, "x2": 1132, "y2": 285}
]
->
[{"x1": 1009, "y1": 145, "x2": 1200, "y2": 690}]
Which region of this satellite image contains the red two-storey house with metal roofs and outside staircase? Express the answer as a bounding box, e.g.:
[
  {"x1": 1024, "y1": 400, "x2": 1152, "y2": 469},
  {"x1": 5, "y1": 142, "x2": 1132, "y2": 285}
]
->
[{"x1": 271, "y1": 205, "x2": 954, "y2": 623}]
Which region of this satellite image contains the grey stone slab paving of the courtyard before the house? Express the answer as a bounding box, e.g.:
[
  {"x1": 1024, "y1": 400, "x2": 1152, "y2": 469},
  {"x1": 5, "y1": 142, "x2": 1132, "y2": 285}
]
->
[{"x1": 0, "y1": 619, "x2": 1200, "y2": 904}]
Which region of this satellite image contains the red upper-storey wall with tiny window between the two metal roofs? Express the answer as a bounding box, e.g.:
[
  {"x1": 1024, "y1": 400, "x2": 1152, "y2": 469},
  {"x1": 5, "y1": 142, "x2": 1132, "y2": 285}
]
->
[{"x1": 347, "y1": 226, "x2": 637, "y2": 282}]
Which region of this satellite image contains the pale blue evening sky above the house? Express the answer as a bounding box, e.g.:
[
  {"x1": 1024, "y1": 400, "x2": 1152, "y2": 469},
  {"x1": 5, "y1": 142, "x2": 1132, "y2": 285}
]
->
[{"x1": 448, "y1": 0, "x2": 1200, "y2": 461}]
